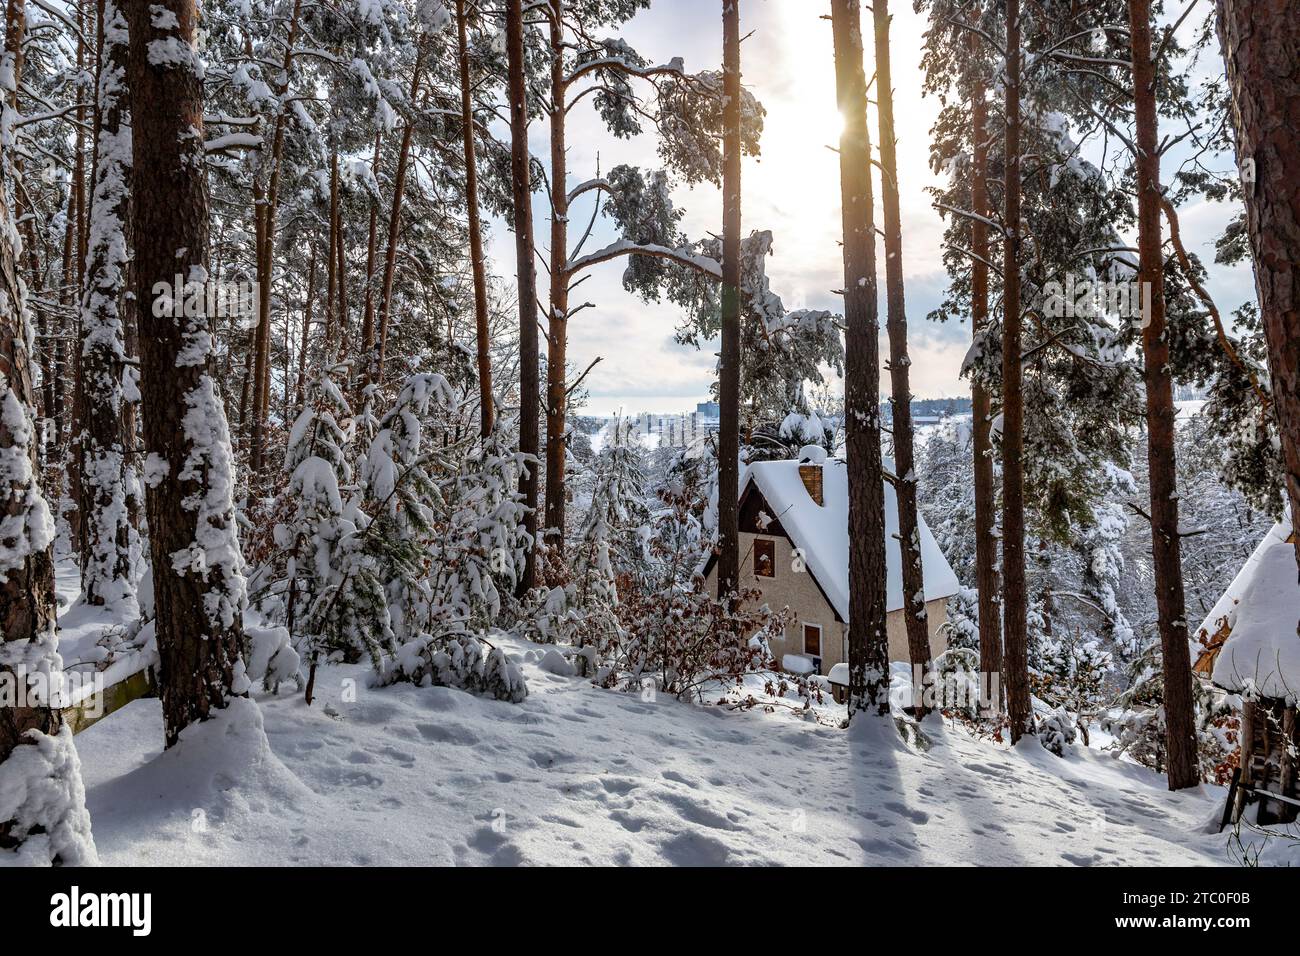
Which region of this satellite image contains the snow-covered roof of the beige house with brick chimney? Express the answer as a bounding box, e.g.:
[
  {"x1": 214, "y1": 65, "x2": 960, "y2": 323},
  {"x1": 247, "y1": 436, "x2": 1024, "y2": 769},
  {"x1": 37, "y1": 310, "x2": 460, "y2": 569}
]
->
[{"x1": 740, "y1": 458, "x2": 959, "y2": 620}]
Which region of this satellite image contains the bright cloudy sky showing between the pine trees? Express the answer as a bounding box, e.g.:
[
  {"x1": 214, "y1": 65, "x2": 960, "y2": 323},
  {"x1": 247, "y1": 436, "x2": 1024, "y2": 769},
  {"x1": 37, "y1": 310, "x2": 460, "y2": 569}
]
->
[{"x1": 489, "y1": 0, "x2": 1253, "y2": 415}]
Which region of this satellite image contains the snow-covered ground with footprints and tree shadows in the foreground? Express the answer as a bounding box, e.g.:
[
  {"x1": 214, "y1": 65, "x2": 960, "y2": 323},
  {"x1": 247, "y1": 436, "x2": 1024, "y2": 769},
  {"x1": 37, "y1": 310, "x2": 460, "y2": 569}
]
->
[{"x1": 68, "y1": 632, "x2": 1268, "y2": 865}]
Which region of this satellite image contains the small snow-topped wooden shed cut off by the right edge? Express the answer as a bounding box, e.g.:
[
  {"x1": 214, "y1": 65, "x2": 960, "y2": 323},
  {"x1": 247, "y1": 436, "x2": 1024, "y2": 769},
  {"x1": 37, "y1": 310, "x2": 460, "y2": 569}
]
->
[{"x1": 1195, "y1": 520, "x2": 1300, "y2": 823}]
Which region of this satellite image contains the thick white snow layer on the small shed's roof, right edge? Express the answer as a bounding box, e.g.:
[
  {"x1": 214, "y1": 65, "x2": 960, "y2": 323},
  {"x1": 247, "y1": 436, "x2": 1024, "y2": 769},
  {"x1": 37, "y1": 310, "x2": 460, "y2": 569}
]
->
[{"x1": 1201, "y1": 520, "x2": 1300, "y2": 702}]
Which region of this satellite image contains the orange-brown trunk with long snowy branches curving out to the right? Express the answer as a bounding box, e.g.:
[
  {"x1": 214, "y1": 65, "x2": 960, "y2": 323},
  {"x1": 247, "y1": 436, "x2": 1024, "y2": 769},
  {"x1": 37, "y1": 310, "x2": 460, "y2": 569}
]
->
[{"x1": 542, "y1": 0, "x2": 569, "y2": 561}]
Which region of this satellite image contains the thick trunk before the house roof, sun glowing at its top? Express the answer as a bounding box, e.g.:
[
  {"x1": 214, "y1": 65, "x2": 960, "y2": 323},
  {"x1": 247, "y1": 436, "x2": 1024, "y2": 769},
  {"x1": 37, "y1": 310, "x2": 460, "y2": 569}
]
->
[{"x1": 831, "y1": 0, "x2": 889, "y2": 718}]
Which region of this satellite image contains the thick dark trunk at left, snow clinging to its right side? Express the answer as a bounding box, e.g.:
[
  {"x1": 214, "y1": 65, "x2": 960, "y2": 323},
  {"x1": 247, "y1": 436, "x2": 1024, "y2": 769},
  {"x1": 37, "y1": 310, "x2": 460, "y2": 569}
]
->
[{"x1": 127, "y1": 0, "x2": 248, "y2": 747}]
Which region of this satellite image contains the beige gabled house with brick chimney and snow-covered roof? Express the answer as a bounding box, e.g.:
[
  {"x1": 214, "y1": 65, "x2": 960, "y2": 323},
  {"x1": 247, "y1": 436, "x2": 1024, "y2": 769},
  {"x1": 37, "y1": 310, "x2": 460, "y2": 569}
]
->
[{"x1": 705, "y1": 449, "x2": 958, "y2": 674}]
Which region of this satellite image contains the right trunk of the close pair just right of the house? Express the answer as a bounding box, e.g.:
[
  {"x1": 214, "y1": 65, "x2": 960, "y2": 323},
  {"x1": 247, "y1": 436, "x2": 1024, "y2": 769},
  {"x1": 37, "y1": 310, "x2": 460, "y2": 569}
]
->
[{"x1": 1002, "y1": 0, "x2": 1034, "y2": 744}]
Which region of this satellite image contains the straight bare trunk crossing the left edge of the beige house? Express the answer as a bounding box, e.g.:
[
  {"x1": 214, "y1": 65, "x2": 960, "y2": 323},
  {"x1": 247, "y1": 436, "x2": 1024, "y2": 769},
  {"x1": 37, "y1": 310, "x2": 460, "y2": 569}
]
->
[{"x1": 718, "y1": 0, "x2": 741, "y2": 604}]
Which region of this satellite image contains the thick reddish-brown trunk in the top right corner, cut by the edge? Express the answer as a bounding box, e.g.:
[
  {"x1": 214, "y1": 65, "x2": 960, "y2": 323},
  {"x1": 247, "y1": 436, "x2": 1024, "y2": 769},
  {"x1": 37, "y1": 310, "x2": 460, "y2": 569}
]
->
[{"x1": 1217, "y1": 0, "x2": 1300, "y2": 570}]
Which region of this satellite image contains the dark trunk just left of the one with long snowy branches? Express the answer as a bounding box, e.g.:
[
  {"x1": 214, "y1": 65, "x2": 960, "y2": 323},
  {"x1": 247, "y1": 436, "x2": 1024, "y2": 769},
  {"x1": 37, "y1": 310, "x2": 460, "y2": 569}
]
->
[{"x1": 506, "y1": 0, "x2": 540, "y2": 597}]
